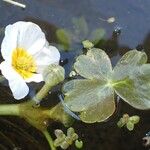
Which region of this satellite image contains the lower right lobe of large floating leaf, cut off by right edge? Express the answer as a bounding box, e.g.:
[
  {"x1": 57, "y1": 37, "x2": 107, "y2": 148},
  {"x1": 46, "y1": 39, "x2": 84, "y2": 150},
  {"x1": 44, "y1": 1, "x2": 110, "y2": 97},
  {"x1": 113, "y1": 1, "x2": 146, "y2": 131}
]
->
[{"x1": 113, "y1": 64, "x2": 150, "y2": 109}]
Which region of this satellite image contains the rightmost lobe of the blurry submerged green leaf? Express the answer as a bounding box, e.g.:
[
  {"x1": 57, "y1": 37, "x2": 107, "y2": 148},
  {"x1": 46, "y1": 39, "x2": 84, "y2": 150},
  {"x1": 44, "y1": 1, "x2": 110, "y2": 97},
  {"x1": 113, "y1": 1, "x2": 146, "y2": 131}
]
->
[{"x1": 89, "y1": 28, "x2": 105, "y2": 44}]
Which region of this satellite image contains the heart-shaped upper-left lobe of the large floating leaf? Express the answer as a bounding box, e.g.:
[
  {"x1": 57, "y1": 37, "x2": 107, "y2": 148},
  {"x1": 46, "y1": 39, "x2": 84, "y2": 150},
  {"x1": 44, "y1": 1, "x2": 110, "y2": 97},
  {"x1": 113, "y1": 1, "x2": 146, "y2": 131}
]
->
[{"x1": 74, "y1": 48, "x2": 112, "y2": 80}]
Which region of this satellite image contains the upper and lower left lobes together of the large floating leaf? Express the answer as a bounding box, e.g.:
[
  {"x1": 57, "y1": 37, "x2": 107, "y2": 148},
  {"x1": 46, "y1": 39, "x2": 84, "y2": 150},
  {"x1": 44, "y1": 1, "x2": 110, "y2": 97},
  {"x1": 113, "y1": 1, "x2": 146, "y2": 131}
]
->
[{"x1": 63, "y1": 48, "x2": 115, "y2": 123}]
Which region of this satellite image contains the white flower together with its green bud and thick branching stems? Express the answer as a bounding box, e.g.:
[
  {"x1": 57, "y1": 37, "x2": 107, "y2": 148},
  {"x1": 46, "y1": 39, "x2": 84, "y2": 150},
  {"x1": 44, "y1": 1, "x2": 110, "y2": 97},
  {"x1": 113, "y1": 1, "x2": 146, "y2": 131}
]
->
[{"x1": 0, "y1": 22, "x2": 72, "y2": 150}]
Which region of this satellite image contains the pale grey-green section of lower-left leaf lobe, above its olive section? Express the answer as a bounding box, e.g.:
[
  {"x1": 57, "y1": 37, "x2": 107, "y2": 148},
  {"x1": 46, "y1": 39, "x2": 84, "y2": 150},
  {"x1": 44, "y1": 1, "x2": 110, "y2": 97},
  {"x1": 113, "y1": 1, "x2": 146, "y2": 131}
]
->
[{"x1": 64, "y1": 79, "x2": 112, "y2": 112}]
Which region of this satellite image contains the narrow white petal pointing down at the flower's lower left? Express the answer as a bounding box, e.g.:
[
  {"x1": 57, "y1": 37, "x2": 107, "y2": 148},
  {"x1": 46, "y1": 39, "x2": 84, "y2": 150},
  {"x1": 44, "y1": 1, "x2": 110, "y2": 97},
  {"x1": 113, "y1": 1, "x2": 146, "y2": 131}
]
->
[{"x1": 0, "y1": 61, "x2": 29, "y2": 100}]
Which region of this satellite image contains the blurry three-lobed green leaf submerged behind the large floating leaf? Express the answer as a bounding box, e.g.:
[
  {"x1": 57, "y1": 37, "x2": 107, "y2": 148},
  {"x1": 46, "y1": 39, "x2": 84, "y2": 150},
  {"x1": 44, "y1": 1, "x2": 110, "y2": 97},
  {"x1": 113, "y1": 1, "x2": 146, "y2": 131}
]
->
[{"x1": 56, "y1": 17, "x2": 105, "y2": 51}]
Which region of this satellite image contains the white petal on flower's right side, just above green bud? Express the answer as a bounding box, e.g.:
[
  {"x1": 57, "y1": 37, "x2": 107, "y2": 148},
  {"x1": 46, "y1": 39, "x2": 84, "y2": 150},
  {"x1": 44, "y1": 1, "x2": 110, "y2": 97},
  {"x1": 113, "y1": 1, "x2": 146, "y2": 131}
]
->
[{"x1": 34, "y1": 46, "x2": 60, "y2": 73}]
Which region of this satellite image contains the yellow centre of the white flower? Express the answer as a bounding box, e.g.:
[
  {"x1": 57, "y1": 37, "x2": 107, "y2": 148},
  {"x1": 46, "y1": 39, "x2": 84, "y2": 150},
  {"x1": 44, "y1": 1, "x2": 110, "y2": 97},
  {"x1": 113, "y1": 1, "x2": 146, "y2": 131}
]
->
[{"x1": 12, "y1": 48, "x2": 37, "y2": 79}]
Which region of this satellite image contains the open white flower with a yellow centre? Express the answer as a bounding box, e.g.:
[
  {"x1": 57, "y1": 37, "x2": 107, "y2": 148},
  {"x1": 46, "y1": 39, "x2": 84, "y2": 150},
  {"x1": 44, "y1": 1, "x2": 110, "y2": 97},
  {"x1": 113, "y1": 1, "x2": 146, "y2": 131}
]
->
[{"x1": 0, "y1": 21, "x2": 60, "y2": 99}]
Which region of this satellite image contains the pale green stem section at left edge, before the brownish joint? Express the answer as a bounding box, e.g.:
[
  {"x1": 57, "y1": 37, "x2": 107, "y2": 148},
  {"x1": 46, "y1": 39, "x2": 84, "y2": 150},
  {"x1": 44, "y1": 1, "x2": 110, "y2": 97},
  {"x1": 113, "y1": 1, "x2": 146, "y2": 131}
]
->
[{"x1": 0, "y1": 104, "x2": 20, "y2": 116}]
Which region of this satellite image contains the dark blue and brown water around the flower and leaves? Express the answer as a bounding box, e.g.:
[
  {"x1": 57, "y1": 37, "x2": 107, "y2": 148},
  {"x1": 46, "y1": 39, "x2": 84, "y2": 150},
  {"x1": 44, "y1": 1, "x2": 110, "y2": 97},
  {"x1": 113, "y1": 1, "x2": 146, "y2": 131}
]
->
[{"x1": 0, "y1": 0, "x2": 150, "y2": 150}]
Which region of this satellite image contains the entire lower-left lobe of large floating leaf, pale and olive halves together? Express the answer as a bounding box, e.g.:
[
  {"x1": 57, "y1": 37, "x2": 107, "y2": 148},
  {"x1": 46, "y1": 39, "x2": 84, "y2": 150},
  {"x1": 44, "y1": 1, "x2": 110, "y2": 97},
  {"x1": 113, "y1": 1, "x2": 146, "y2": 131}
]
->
[{"x1": 63, "y1": 79, "x2": 115, "y2": 123}]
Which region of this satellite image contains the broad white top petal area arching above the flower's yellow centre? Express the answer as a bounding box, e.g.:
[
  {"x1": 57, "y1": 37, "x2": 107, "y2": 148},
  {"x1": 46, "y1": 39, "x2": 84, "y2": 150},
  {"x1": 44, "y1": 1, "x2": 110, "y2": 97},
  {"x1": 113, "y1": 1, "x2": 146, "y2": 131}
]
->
[{"x1": 1, "y1": 21, "x2": 46, "y2": 61}]
